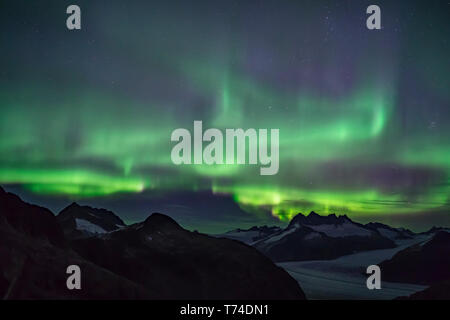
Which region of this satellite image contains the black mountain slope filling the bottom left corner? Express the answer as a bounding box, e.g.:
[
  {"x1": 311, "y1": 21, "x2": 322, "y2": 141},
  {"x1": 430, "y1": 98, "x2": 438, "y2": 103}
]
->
[{"x1": 0, "y1": 188, "x2": 151, "y2": 299}]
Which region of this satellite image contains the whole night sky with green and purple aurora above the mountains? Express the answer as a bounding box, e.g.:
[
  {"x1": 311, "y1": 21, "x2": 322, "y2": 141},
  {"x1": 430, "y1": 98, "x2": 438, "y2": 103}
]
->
[{"x1": 0, "y1": 0, "x2": 450, "y2": 230}]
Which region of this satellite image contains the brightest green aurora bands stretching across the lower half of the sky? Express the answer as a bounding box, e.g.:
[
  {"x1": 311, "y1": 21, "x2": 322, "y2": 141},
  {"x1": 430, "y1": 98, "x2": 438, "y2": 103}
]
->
[{"x1": 0, "y1": 79, "x2": 449, "y2": 221}]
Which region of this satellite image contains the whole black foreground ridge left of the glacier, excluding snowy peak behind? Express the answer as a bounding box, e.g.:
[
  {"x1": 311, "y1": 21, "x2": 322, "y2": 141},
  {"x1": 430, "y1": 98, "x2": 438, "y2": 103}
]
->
[{"x1": 0, "y1": 188, "x2": 305, "y2": 299}]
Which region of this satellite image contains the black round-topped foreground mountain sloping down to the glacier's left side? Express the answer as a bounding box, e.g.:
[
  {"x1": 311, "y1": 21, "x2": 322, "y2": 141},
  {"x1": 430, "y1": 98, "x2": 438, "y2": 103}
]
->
[{"x1": 73, "y1": 213, "x2": 304, "y2": 299}]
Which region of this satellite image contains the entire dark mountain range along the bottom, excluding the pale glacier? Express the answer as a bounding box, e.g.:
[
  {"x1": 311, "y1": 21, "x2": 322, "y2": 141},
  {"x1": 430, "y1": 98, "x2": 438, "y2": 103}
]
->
[{"x1": 0, "y1": 188, "x2": 450, "y2": 300}]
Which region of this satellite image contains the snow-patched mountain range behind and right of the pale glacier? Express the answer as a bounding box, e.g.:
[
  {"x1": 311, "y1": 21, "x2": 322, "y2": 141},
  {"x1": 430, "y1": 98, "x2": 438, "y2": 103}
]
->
[{"x1": 214, "y1": 212, "x2": 450, "y2": 300}]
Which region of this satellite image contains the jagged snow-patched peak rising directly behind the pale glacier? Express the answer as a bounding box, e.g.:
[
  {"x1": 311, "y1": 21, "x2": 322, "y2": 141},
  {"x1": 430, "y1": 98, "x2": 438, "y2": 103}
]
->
[{"x1": 254, "y1": 212, "x2": 395, "y2": 262}]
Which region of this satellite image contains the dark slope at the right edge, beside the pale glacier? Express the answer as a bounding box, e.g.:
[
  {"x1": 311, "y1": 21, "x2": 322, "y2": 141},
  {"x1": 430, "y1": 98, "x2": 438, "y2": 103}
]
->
[{"x1": 380, "y1": 231, "x2": 450, "y2": 284}]
